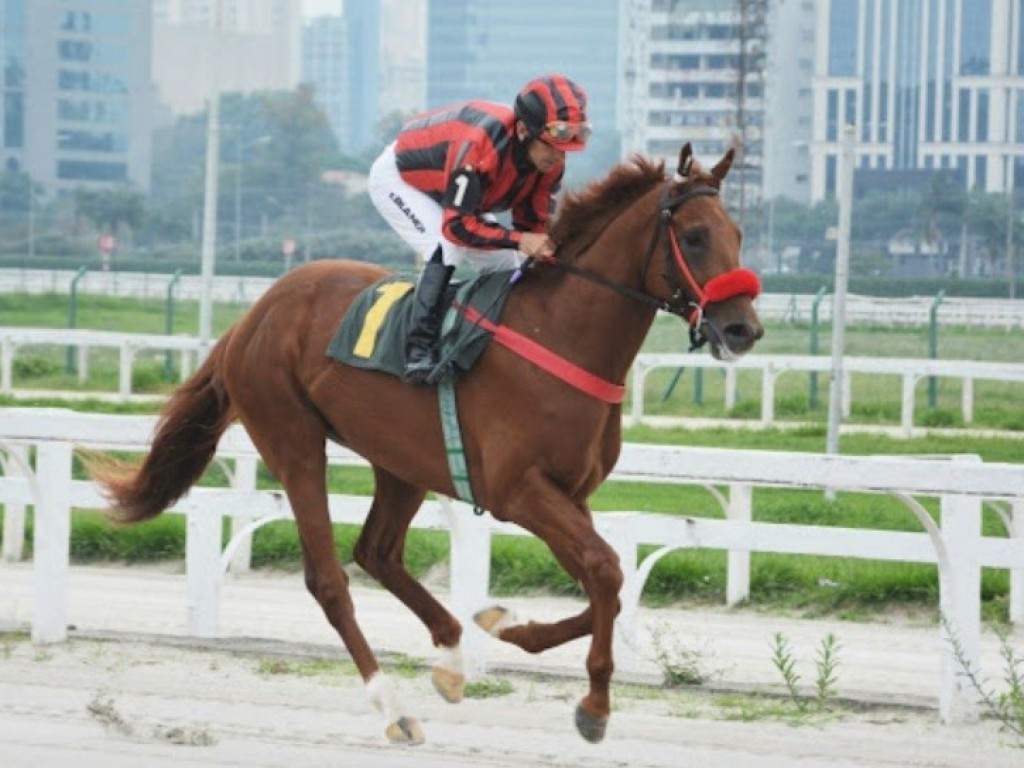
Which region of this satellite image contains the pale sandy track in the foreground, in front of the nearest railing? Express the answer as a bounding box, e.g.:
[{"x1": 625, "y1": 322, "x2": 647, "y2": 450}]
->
[{"x1": 0, "y1": 639, "x2": 1022, "y2": 768}]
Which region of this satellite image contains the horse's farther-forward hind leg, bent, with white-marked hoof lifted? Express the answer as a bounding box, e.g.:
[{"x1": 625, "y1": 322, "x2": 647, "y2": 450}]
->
[{"x1": 354, "y1": 467, "x2": 466, "y2": 703}]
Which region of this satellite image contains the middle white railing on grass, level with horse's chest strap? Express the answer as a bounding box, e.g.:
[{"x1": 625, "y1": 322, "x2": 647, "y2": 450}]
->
[{"x1": 0, "y1": 327, "x2": 1024, "y2": 437}]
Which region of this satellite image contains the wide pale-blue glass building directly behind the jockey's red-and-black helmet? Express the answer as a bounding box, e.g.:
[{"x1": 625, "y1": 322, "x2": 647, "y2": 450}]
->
[{"x1": 427, "y1": 0, "x2": 618, "y2": 153}]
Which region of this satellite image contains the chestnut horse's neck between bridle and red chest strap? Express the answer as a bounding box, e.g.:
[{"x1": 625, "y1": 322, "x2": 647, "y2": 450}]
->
[{"x1": 528, "y1": 193, "x2": 657, "y2": 382}]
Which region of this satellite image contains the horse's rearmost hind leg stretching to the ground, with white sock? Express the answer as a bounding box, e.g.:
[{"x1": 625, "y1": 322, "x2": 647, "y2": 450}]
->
[{"x1": 242, "y1": 398, "x2": 424, "y2": 744}]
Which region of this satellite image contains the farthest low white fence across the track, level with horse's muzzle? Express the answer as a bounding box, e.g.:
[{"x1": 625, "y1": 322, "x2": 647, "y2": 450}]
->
[{"x1": 0, "y1": 268, "x2": 1024, "y2": 331}]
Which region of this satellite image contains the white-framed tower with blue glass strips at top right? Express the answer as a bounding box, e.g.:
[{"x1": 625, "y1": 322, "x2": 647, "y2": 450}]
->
[{"x1": 811, "y1": 0, "x2": 1024, "y2": 201}]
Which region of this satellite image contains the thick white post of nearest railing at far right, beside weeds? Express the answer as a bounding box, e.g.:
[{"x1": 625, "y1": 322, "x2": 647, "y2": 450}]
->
[{"x1": 939, "y1": 496, "x2": 981, "y2": 723}]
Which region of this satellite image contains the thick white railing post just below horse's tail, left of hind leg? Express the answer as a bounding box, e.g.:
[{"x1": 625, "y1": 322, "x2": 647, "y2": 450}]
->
[{"x1": 185, "y1": 500, "x2": 221, "y2": 637}]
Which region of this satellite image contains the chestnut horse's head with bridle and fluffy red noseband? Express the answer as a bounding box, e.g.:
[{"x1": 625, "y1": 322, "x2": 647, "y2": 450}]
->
[{"x1": 644, "y1": 142, "x2": 764, "y2": 359}]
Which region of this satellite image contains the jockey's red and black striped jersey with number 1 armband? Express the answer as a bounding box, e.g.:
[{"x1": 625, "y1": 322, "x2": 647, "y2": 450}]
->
[{"x1": 395, "y1": 101, "x2": 563, "y2": 250}]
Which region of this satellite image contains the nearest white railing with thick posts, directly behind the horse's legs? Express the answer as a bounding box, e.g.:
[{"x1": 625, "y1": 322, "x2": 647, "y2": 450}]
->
[{"x1": 0, "y1": 409, "x2": 1024, "y2": 722}]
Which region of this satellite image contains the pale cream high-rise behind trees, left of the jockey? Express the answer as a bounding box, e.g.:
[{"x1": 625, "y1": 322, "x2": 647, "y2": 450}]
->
[{"x1": 153, "y1": 0, "x2": 302, "y2": 115}]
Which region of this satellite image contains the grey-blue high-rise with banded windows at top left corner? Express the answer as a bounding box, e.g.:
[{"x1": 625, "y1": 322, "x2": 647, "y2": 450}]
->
[{"x1": 0, "y1": 0, "x2": 153, "y2": 194}]
